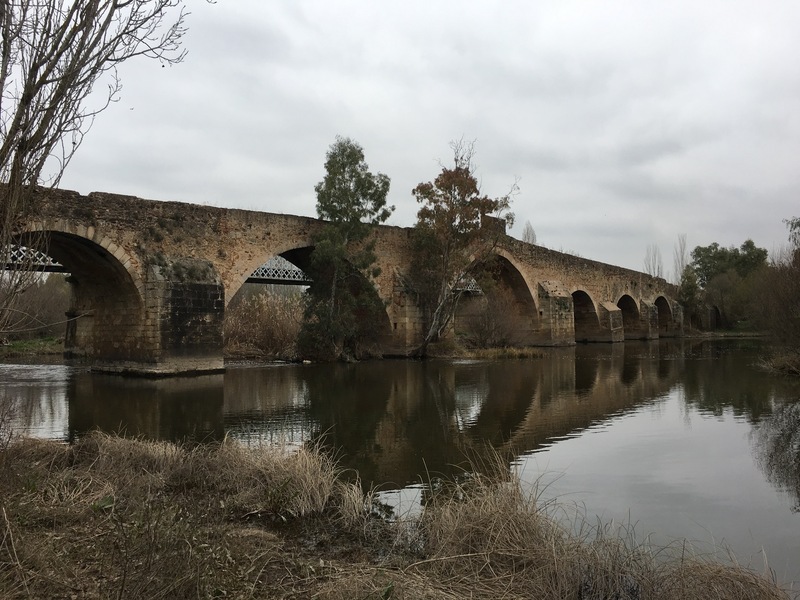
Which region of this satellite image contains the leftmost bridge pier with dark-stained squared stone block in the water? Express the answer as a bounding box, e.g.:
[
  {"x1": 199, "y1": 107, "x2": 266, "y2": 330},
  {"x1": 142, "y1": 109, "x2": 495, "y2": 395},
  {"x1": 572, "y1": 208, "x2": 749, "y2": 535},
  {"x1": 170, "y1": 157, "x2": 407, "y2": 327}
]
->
[{"x1": 64, "y1": 257, "x2": 225, "y2": 376}]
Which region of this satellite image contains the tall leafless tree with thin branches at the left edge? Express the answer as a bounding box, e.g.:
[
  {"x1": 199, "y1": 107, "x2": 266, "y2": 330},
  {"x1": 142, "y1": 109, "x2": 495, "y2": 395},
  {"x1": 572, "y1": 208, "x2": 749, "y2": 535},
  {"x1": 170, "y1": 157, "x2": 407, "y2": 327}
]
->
[{"x1": 0, "y1": 0, "x2": 197, "y2": 332}]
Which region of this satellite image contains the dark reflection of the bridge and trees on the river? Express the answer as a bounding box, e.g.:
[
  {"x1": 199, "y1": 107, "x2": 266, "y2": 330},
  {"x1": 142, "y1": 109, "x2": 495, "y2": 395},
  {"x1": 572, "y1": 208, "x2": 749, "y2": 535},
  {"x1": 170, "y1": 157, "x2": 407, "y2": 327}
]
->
[{"x1": 6, "y1": 340, "x2": 784, "y2": 487}]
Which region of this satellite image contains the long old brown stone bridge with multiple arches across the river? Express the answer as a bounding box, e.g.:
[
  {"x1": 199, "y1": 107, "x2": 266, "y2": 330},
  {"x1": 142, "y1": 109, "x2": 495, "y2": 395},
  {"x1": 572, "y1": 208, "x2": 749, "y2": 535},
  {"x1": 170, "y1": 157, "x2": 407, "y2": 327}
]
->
[{"x1": 16, "y1": 190, "x2": 683, "y2": 375}]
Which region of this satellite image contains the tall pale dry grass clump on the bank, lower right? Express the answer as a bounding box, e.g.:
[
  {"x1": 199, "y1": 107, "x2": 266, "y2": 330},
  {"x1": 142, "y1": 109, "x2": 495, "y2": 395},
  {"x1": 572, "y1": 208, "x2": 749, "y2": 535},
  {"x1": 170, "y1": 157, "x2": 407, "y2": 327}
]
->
[{"x1": 390, "y1": 464, "x2": 787, "y2": 600}]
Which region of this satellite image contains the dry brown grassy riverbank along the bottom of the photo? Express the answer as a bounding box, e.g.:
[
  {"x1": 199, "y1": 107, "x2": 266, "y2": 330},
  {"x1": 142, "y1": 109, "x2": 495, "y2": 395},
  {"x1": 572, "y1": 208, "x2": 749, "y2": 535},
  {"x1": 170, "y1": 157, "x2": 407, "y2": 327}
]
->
[{"x1": 0, "y1": 434, "x2": 787, "y2": 600}]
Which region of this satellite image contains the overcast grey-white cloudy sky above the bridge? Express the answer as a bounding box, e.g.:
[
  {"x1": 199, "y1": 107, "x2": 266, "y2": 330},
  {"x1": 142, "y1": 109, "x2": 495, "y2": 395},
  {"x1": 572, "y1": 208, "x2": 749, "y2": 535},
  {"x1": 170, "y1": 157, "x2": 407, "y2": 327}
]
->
[{"x1": 61, "y1": 0, "x2": 800, "y2": 275}]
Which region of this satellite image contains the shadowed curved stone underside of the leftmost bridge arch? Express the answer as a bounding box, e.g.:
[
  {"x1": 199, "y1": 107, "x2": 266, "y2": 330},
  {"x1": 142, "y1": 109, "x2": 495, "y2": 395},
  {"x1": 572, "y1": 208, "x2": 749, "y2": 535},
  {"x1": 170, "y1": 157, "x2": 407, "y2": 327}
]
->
[{"x1": 14, "y1": 229, "x2": 147, "y2": 362}]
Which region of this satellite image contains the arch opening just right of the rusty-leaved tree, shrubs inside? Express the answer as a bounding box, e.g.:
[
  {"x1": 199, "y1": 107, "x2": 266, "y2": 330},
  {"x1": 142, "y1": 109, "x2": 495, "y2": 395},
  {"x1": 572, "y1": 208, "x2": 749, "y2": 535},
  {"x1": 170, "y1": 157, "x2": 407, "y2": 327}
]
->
[{"x1": 454, "y1": 255, "x2": 541, "y2": 347}]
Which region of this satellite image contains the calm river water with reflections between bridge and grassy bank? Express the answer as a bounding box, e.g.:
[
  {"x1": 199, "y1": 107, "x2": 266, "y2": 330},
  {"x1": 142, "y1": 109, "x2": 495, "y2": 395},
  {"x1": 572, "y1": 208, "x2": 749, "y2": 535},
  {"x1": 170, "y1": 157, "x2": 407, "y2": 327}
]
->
[{"x1": 0, "y1": 340, "x2": 800, "y2": 590}]
